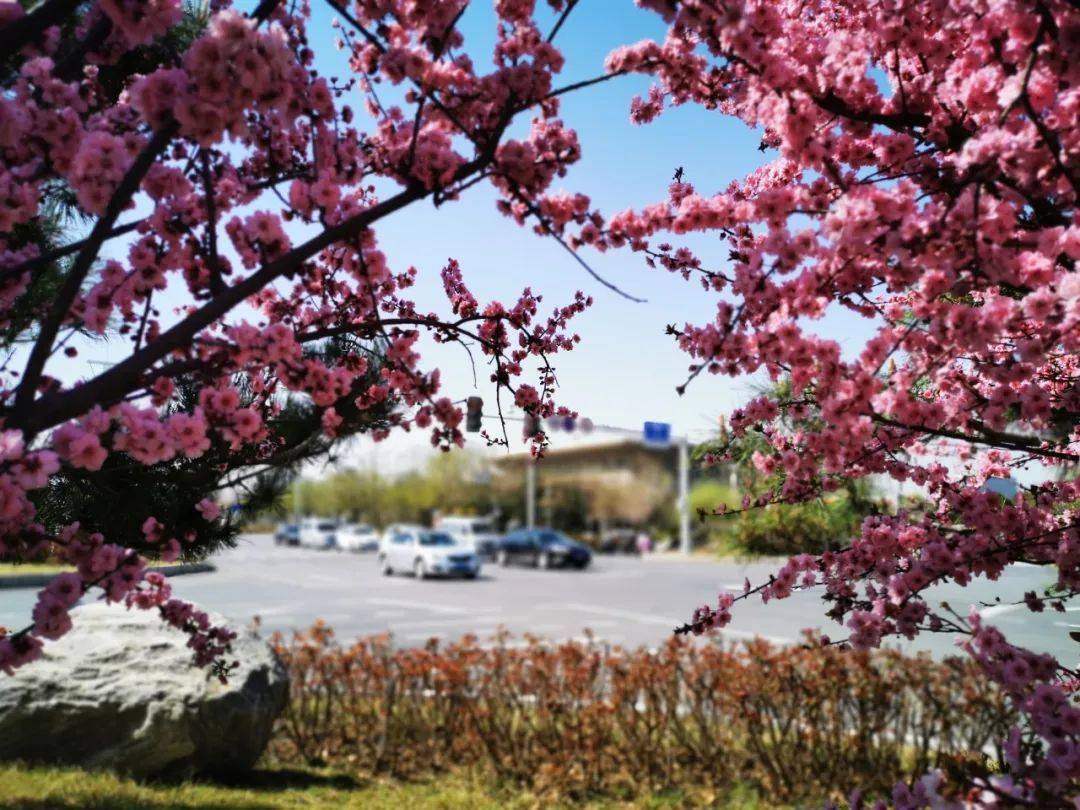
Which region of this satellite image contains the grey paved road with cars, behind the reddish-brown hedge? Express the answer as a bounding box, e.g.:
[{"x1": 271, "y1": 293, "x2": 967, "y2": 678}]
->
[{"x1": 0, "y1": 535, "x2": 1080, "y2": 664}]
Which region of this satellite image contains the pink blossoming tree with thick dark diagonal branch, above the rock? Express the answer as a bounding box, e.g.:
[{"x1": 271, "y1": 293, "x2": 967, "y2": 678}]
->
[{"x1": 0, "y1": 0, "x2": 589, "y2": 674}]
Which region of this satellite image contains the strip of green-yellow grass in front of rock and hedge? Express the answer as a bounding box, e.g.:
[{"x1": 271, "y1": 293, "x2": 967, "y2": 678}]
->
[{"x1": 0, "y1": 765, "x2": 760, "y2": 810}]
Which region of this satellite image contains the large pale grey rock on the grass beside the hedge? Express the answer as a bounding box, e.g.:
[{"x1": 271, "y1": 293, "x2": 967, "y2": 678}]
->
[{"x1": 0, "y1": 604, "x2": 288, "y2": 777}]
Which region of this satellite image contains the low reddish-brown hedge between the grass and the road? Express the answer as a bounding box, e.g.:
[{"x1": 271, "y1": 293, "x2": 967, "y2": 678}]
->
[{"x1": 271, "y1": 623, "x2": 1012, "y2": 801}]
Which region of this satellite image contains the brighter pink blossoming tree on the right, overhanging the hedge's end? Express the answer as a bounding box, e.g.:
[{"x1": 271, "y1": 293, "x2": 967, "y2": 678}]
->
[{"x1": 573, "y1": 0, "x2": 1080, "y2": 807}]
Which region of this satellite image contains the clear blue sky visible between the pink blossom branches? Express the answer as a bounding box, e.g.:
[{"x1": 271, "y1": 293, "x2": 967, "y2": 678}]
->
[{"x1": 44, "y1": 0, "x2": 885, "y2": 472}]
